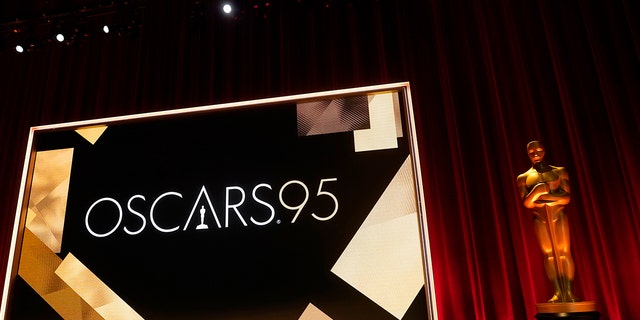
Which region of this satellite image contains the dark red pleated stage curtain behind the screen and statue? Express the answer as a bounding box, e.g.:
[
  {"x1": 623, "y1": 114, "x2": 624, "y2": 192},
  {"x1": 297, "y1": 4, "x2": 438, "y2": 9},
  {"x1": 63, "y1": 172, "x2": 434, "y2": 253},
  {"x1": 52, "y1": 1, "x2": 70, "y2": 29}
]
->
[{"x1": 0, "y1": 0, "x2": 640, "y2": 319}]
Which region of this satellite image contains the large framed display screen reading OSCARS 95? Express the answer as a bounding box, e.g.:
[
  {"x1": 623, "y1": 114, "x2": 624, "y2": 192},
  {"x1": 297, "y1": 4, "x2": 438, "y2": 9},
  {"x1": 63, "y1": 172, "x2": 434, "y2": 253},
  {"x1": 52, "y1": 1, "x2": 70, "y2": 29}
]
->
[{"x1": 2, "y1": 83, "x2": 435, "y2": 320}]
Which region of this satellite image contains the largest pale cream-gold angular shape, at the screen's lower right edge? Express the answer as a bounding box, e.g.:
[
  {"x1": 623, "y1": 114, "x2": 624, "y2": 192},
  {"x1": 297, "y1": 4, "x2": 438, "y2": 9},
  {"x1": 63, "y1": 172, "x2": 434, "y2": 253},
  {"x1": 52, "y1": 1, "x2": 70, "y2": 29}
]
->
[{"x1": 331, "y1": 158, "x2": 424, "y2": 319}]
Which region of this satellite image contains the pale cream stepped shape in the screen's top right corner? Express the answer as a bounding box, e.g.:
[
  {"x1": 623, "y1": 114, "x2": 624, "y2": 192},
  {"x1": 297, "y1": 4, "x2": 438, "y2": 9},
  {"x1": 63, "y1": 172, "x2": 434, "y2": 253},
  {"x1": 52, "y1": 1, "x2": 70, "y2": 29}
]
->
[{"x1": 353, "y1": 92, "x2": 402, "y2": 152}]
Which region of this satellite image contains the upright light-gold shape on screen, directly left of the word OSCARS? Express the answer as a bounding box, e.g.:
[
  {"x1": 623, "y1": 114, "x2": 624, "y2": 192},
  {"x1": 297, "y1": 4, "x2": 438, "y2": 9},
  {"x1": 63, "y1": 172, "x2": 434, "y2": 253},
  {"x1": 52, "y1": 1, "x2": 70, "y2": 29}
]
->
[{"x1": 26, "y1": 148, "x2": 73, "y2": 253}]
